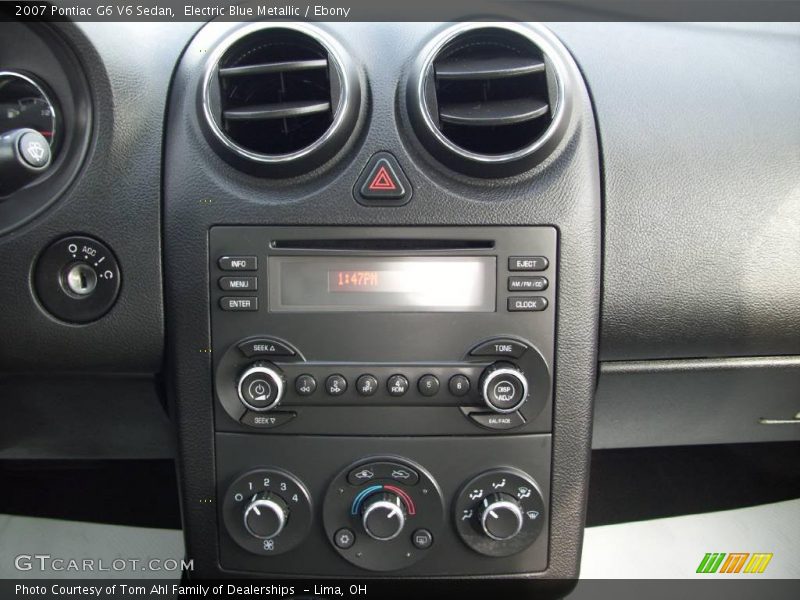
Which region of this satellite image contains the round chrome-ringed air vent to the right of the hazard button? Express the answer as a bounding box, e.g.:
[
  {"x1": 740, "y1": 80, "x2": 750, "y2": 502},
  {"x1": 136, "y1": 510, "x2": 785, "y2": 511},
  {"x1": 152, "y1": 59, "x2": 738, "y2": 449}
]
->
[{"x1": 407, "y1": 23, "x2": 570, "y2": 177}]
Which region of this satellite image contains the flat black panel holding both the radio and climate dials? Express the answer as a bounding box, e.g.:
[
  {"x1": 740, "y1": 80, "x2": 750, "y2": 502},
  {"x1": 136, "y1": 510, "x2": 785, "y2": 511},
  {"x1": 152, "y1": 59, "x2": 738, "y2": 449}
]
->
[{"x1": 209, "y1": 227, "x2": 558, "y2": 575}]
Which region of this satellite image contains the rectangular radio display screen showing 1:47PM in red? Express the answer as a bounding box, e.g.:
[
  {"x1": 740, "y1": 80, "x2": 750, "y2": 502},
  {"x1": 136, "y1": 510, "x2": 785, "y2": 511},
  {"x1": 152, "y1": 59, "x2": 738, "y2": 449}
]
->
[{"x1": 269, "y1": 256, "x2": 497, "y2": 312}]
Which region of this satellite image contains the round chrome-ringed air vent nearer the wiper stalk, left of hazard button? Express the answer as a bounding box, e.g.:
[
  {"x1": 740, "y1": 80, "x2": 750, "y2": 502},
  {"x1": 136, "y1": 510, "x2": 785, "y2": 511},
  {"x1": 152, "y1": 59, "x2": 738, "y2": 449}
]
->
[{"x1": 202, "y1": 23, "x2": 361, "y2": 177}]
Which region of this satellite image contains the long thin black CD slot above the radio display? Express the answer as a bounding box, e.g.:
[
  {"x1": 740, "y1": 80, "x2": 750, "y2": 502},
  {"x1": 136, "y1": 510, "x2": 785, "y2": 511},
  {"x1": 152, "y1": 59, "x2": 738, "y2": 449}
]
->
[{"x1": 270, "y1": 238, "x2": 494, "y2": 252}]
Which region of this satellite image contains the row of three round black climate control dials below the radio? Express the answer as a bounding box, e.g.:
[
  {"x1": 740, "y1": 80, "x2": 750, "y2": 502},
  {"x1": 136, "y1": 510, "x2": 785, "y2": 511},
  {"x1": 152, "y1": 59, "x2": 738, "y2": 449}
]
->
[{"x1": 216, "y1": 455, "x2": 547, "y2": 572}]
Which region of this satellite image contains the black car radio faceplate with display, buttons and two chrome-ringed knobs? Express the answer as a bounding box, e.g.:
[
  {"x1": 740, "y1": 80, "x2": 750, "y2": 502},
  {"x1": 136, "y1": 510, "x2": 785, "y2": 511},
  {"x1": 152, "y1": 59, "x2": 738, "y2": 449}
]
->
[{"x1": 209, "y1": 226, "x2": 558, "y2": 435}]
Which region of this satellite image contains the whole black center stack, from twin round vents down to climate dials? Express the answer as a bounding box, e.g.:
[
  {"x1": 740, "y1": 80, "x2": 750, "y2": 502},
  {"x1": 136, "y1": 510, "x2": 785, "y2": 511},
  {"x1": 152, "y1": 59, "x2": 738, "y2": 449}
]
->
[{"x1": 163, "y1": 22, "x2": 600, "y2": 595}]
